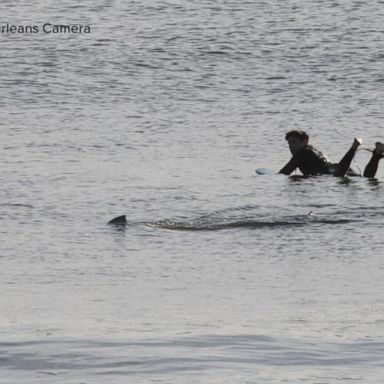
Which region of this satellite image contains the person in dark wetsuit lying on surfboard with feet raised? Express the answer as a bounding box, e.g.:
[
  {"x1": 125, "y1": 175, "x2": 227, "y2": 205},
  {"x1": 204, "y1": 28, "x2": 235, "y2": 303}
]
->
[{"x1": 279, "y1": 130, "x2": 384, "y2": 177}]
